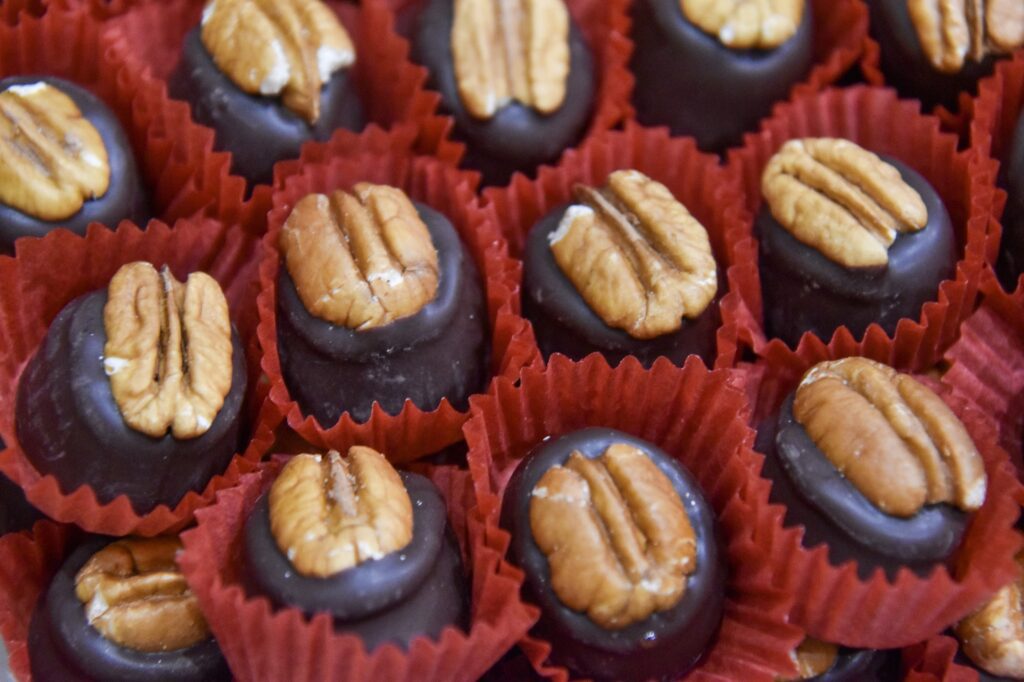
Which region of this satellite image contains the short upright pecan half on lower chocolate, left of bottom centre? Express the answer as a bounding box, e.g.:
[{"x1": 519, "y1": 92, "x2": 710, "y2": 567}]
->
[{"x1": 269, "y1": 445, "x2": 413, "y2": 578}]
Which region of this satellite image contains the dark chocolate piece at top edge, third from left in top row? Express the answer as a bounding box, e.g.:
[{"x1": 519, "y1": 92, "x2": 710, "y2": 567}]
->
[{"x1": 631, "y1": 0, "x2": 814, "y2": 152}]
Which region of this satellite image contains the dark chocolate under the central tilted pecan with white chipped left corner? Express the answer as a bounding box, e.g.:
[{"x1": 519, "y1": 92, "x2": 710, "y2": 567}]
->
[{"x1": 522, "y1": 204, "x2": 724, "y2": 367}]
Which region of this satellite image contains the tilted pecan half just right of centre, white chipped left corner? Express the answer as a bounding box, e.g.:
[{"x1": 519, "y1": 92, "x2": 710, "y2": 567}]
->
[{"x1": 549, "y1": 170, "x2": 718, "y2": 339}]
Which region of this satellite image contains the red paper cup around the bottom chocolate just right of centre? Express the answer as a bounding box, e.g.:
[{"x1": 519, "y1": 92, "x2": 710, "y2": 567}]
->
[{"x1": 464, "y1": 354, "x2": 803, "y2": 680}]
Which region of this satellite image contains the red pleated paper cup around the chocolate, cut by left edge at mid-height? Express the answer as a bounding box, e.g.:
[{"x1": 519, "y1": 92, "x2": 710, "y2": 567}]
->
[{"x1": 0, "y1": 219, "x2": 280, "y2": 536}]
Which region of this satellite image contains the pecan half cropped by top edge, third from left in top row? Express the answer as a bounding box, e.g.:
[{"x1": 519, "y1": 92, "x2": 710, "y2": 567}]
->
[{"x1": 680, "y1": 0, "x2": 805, "y2": 50}]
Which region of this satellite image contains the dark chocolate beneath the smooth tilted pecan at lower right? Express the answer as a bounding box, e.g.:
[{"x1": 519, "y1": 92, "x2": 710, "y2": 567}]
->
[{"x1": 758, "y1": 394, "x2": 970, "y2": 580}]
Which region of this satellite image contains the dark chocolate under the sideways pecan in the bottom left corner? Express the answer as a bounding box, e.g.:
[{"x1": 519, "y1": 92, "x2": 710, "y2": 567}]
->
[{"x1": 29, "y1": 538, "x2": 231, "y2": 682}]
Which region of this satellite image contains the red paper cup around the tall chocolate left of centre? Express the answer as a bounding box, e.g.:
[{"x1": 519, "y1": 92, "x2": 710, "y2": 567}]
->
[{"x1": 257, "y1": 150, "x2": 538, "y2": 462}]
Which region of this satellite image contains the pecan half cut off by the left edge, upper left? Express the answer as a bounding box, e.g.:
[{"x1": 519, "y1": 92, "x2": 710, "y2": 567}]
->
[{"x1": 0, "y1": 83, "x2": 111, "y2": 220}]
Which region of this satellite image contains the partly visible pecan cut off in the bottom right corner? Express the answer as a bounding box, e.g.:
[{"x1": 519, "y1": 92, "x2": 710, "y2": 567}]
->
[{"x1": 955, "y1": 554, "x2": 1024, "y2": 679}]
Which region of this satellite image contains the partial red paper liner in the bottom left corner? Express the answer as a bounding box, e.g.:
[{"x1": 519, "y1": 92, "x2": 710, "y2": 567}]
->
[{"x1": 0, "y1": 521, "x2": 75, "y2": 682}]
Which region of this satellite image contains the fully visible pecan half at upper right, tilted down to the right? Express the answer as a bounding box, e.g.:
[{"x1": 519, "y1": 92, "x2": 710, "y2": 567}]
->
[{"x1": 761, "y1": 137, "x2": 928, "y2": 267}]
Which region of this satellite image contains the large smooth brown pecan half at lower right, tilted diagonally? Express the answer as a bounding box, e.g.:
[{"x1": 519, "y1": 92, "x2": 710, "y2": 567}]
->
[{"x1": 793, "y1": 357, "x2": 987, "y2": 517}]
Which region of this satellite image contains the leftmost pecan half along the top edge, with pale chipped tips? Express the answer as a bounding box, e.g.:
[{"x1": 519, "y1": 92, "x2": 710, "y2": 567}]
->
[{"x1": 200, "y1": 0, "x2": 355, "y2": 123}]
